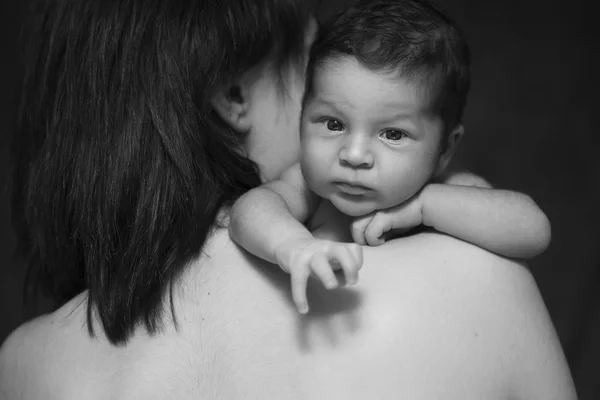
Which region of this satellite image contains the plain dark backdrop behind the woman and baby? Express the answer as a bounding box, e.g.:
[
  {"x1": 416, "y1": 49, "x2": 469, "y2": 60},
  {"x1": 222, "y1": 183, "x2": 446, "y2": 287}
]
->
[{"x1": 0, "y1": 0, "x2": 600, "y2": 400}]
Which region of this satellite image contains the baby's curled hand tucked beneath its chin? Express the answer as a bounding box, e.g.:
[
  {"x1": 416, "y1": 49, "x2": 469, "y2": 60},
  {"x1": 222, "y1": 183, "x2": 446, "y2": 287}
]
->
[{"x1": 352, "y1": 193, "x2": 423, "y2": 246}]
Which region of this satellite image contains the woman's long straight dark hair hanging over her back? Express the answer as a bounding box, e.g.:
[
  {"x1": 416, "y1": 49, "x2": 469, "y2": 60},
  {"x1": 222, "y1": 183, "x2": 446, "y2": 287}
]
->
[{"x1": 12, "y1": 0, "x2": 310, "y2": 342}]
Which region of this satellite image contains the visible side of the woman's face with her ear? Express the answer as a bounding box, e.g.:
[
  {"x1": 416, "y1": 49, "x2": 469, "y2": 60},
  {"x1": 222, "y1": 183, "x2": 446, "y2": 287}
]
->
[{"x1": 212, "y1": 19, "x2": 317, "y2": 181}]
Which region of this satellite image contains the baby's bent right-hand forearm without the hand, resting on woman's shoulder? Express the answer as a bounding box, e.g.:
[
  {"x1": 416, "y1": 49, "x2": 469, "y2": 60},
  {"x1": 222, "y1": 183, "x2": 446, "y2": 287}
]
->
[{"x1": 419, "y1": 184, "x2": 550, "y2": 258}]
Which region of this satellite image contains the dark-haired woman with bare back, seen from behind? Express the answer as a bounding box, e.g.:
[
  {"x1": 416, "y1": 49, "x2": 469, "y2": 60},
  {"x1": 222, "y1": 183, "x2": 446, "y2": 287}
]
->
[{"x1": 0, "y1": 0, "x2": 575, "y2": 400}]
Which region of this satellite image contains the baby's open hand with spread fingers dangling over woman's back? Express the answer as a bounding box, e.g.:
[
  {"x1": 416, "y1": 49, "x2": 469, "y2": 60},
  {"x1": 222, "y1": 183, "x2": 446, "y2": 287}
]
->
[{"x1": 275, "y1": 238, "x2": 362, "y2": 314}]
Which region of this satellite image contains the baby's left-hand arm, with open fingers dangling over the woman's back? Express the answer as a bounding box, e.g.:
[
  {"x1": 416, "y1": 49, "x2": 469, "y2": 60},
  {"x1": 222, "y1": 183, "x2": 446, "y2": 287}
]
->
[{"x1": 229, "y1": 164, "x2": 362, "y2": 313}]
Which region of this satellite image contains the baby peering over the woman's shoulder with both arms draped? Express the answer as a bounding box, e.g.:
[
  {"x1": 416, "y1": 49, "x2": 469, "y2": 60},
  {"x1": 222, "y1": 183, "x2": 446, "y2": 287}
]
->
[{"x1": 229, "y1": 0, "x2": 550, "y2": 313}]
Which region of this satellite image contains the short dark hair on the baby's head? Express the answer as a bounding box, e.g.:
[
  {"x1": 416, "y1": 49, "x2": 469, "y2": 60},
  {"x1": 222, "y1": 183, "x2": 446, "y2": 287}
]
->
[{"x1": 305, "y1": 0, "x2": 470, "y2": 133}]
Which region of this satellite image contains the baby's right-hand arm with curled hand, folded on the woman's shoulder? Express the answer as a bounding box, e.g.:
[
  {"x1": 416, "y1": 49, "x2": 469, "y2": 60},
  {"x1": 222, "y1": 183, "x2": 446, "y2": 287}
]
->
[{"x1": 352, "y1": 180, "x2": 550, "y2": 258}]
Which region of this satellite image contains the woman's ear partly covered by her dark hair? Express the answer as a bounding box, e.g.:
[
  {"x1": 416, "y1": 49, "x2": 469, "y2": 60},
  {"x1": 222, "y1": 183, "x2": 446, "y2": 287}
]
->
[{"x1": 210, "y1": 84, "x2": 251, "y2": 132}]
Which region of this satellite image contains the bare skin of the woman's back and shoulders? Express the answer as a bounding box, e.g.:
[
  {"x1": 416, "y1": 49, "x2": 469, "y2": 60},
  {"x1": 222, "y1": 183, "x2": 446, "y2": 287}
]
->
[{"x1": 0, "y1": 229, "x2": 576, "y2": 400}]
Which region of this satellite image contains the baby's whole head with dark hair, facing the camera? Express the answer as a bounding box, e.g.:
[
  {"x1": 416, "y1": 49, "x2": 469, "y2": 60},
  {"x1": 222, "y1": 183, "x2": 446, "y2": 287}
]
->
[{"x1": 301, "y1": 0, "x2": 469, "y2": 216}]
